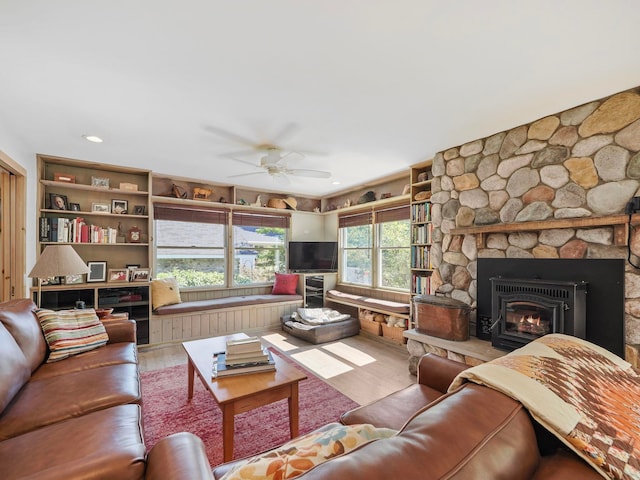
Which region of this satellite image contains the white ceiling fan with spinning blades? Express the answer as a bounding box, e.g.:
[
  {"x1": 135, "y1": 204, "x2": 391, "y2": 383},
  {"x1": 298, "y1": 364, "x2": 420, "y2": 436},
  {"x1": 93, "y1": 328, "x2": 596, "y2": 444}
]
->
[{"x1": 206, "y1": 124, "x2": 331, "y2": 183}]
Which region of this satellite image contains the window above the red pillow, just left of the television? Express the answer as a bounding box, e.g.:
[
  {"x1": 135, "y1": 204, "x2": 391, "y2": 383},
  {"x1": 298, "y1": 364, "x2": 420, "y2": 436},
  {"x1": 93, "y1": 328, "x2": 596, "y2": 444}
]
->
[{"x1": 231, "y1": 212, "x2": 290, "y2": 285}]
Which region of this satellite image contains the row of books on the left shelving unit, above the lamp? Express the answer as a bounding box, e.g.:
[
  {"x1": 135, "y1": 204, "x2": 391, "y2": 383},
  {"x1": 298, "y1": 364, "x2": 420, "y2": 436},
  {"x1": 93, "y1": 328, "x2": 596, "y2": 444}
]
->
[{"x1": 39, "y1": 217, "x2": 118, "y2": 243}]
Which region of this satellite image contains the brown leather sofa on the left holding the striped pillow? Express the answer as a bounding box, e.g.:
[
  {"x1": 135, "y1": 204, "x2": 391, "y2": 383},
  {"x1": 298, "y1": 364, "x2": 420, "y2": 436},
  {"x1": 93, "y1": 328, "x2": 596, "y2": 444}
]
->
[{"x1": 0, "y1": 299, "x2": 211, "y2": 480}]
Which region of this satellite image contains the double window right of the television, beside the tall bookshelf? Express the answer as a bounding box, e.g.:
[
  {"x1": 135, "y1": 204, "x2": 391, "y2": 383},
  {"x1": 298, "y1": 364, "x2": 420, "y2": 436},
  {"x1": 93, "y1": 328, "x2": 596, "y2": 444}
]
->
[{"x1": 338, "y1": 205, "x2": 411, "y2": 290}]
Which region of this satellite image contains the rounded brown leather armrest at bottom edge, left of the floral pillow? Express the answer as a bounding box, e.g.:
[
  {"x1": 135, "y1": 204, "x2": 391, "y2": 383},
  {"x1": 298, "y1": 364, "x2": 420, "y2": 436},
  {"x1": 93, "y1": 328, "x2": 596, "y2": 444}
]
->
[{"x1": 145, "y1": 432, "x2": 213, "y2": 480}]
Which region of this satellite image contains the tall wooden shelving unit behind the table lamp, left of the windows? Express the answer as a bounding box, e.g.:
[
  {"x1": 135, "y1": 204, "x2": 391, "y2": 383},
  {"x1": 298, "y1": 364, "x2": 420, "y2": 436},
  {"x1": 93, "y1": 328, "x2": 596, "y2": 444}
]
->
[{"x1": 32, "y1": 155, "x2": 153, "y2": 343}]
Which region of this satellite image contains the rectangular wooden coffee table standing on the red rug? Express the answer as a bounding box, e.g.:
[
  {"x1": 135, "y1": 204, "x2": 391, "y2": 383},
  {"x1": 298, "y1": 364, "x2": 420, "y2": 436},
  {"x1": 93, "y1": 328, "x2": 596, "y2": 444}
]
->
[{"x1": 182, "y1": 333, "x2": 307, "y2": 462}]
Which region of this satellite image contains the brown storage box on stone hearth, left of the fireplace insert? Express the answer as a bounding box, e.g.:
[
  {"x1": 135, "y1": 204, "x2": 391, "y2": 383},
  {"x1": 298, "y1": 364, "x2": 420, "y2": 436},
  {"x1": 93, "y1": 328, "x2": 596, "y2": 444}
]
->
[{"x1": 414, "y1": 295, "x2": 471, "y2": 341}]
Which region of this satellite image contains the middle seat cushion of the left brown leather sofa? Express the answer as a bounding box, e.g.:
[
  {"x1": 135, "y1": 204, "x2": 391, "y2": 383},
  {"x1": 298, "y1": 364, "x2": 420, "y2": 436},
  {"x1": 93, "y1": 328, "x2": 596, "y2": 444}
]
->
[{"x1": 0, "y1": 360, "x2": 140, "y2": 440}]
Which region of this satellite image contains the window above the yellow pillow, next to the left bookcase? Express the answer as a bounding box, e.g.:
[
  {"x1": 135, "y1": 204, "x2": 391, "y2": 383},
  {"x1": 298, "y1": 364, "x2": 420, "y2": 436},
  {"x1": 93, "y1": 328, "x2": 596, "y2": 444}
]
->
[{"x1": 154, "y1": 205, "x2": 229, "y2": 287}]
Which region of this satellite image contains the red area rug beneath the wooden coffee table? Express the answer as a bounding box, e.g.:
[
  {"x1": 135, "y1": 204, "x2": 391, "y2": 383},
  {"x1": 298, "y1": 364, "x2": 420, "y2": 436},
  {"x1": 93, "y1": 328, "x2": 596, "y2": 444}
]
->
[{"x1": 141, "y1": 355, "x2": 358, "y2": 466}]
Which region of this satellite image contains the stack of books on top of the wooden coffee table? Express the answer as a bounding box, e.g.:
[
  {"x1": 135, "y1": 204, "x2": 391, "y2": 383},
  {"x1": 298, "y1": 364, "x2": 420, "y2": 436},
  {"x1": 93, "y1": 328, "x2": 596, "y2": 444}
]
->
[{"x1": 213, "y1": 337, "x2": 276, "y2": 378}]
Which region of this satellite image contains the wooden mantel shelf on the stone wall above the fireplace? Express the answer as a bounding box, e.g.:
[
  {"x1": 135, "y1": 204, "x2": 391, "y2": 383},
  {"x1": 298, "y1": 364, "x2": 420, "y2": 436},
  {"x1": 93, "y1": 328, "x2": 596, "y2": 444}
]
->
[{"x1": 451, "y1": 214, "x2": 640, "y2": 248}]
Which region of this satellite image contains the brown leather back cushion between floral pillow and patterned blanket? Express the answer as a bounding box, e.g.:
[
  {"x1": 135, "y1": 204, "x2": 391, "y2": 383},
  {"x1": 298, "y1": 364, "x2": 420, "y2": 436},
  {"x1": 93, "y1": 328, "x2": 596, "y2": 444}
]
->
[{"x1": 296, "y1": 384, "x2": 540, "y2": 480}]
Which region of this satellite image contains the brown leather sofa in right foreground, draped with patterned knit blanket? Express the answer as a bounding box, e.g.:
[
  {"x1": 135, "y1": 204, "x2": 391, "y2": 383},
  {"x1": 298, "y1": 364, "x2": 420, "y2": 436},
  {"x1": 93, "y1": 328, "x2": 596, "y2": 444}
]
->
[{"x1": 213, "y1": 355, "x2": 602, "y2": 480}]
